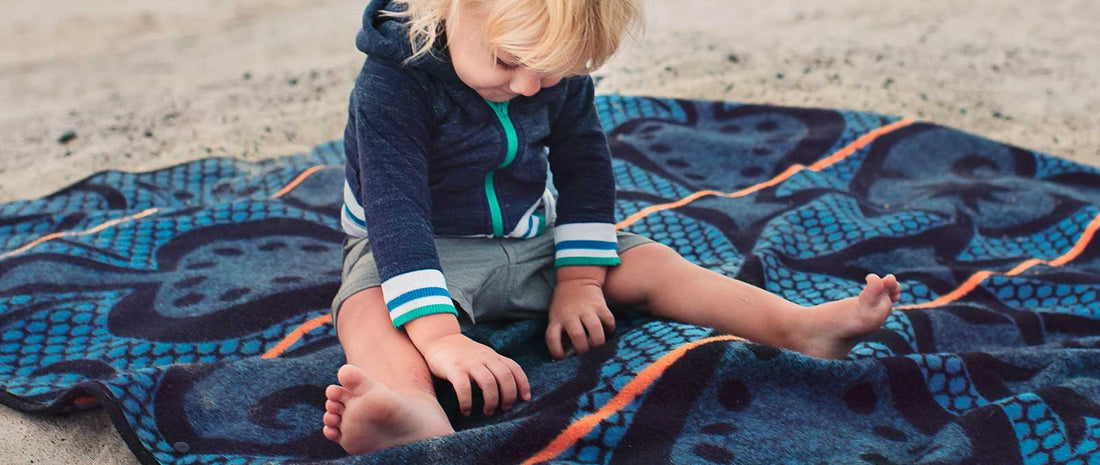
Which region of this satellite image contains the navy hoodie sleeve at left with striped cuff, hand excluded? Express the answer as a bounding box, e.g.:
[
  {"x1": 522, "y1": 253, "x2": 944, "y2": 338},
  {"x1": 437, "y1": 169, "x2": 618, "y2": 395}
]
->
[{"x1": 344, "y1": 58, "x2": 458, "y2": 326}]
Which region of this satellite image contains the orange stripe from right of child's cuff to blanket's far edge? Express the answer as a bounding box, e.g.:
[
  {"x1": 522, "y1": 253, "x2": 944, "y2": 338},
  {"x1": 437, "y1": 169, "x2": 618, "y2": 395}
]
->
[{"x1": 615, "y1": 118, "x2": 913, "y2": 230}]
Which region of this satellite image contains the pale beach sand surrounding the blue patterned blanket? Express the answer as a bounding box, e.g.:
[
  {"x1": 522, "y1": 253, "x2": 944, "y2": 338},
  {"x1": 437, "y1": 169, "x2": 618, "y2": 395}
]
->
[{"x1": 0, "y1": 0, "x2": 1100, "y2": 465}]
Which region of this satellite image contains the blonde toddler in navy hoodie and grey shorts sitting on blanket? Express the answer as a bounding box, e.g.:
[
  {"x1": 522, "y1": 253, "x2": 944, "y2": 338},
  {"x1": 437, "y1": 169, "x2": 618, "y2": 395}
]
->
[{"x1": 323, "y1": 0, "x2": 900, "y2": 454}]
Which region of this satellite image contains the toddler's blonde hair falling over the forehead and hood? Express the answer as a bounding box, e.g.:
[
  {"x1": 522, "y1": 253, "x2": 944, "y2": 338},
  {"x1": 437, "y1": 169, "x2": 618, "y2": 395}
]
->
[{"x1": 383, "y1": 0, "x2": 641, "y2": 76}]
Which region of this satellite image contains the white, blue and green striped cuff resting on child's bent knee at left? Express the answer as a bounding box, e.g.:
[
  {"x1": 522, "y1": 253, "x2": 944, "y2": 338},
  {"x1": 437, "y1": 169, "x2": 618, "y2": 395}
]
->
[{"x1": 382, "y1": 269, "x2": 459, "y2": 328}]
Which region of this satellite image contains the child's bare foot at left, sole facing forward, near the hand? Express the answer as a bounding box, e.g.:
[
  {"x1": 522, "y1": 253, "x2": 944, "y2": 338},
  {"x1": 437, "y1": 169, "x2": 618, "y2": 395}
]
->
[{"x1": 323, "y1": 365, "x2": 454, "y2": 454}]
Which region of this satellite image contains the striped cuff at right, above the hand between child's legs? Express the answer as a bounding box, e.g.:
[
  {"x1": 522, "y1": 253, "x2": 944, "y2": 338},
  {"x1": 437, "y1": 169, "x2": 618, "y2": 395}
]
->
[{"x1": 553, "y1": 223, "x2": 619, "y2": 268}]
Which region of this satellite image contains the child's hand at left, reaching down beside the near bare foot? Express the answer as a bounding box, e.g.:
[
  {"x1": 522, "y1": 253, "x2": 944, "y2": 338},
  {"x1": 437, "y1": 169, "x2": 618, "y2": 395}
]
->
[{"x1": 420, "y1": 334, "x2": 531, "y2": 416}]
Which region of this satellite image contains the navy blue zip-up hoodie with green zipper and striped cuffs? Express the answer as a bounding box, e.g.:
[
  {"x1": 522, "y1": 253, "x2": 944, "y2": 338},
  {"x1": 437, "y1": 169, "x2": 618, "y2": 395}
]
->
[{"x1": 341, "y1": 0, "x2": 619, "y2": 326}]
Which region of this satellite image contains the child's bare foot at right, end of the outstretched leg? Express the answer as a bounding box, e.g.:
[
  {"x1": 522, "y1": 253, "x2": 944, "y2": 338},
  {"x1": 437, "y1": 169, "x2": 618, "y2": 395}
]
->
[{"x1": 790, "y1": 274, "x2": 901, "y2": 358}]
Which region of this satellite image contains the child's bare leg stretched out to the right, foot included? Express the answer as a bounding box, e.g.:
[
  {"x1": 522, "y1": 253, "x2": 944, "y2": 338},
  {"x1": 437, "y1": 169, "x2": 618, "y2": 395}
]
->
[{"x1": 604, "y1": 244, "x2": 901, "y2": 358}]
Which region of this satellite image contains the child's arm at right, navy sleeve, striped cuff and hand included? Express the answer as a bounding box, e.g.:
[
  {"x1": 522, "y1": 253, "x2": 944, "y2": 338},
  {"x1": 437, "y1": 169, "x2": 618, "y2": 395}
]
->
[{"x1": 546, "y1": 76, "x2": 619, "y2": 358}]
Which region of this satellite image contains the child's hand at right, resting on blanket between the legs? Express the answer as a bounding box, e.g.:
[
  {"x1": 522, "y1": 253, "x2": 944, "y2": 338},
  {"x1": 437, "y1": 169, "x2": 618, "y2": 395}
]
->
[{"x1": 547, "y1": 279, "x2": 615, "y2": 359}]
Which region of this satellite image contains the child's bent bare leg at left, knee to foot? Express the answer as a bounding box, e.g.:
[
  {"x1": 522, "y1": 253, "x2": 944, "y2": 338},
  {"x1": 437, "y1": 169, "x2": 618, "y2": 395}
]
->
[{"x1": 323, "y1": 287, "x2": 454, "y2": 454}]
